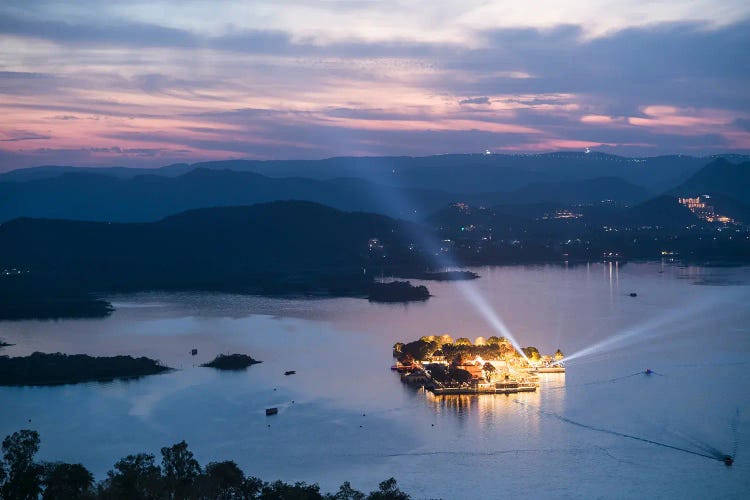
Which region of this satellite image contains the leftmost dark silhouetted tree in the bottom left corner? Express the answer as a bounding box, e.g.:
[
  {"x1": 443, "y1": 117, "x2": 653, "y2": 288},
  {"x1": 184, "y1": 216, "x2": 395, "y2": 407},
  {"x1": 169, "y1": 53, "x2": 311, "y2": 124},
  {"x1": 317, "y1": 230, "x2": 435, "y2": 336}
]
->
[{"x1": 2, "y1": 429, "x2": 42, "y2": 500}]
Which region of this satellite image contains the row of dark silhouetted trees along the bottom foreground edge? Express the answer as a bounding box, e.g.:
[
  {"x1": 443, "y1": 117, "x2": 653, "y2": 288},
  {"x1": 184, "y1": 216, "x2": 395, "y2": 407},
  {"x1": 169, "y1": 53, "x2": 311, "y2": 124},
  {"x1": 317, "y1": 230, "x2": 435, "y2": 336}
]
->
[{"x1": 0, "y1": 430, "x2": 409, "y2": 500}]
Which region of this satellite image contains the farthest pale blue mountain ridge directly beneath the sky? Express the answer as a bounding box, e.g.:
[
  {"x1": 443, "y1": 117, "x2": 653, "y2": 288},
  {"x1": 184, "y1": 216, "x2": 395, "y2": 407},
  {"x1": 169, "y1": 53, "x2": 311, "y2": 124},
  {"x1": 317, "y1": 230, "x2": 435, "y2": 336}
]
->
[{"x1": 0, "y1": 152, "x2": 736, "y2": 193}]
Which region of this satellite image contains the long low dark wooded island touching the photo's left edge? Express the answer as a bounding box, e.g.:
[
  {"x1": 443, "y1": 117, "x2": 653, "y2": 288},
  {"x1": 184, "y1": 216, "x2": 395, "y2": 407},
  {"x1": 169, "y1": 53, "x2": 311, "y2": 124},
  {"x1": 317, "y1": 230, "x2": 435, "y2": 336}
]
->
[{"x1": 0, "y1": 352, "x2": 171, "y2": 386}]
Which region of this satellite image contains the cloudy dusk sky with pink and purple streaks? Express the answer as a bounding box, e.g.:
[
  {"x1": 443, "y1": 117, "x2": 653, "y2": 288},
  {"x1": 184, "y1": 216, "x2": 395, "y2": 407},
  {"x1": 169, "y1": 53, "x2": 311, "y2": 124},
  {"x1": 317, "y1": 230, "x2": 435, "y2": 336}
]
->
[{"x1": 0, "y1": 0, "x2": 750, "y2": 171}]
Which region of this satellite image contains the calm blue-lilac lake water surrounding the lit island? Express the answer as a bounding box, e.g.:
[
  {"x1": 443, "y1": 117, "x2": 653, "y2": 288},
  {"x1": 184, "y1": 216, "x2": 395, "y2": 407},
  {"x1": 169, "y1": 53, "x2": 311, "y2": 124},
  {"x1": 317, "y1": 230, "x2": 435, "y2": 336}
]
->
[{"x1": 0, "y1": 263, "x2": 750, "y2": 498}]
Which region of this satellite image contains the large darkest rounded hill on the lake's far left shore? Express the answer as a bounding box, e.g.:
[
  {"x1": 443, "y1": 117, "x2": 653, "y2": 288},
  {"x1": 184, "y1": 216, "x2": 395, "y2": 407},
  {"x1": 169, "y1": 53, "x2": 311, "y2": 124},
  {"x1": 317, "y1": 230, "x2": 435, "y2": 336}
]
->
[{"x1": 0, "y1": 202, "x2": 424, "y2": 294}]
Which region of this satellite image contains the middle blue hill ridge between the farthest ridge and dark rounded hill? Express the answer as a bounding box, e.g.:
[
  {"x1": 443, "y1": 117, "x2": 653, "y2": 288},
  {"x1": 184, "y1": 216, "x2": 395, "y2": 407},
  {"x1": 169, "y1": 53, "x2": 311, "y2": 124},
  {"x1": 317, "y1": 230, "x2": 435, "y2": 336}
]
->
[{"x1": 0, "y1": 168, "x2": 660, "y2": 222}]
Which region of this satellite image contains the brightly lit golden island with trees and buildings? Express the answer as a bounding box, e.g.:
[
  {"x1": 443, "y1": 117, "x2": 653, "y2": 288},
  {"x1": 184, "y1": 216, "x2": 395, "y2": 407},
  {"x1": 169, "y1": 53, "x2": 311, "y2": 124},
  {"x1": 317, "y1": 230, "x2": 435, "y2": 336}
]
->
[{"x1": 391, "y1": 335, "x2": 565, "y2": 395}]
